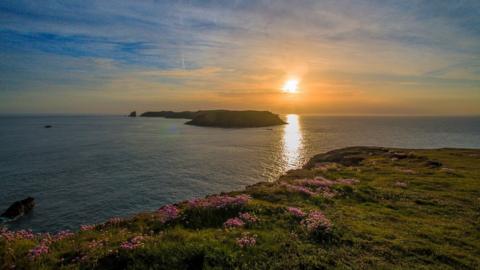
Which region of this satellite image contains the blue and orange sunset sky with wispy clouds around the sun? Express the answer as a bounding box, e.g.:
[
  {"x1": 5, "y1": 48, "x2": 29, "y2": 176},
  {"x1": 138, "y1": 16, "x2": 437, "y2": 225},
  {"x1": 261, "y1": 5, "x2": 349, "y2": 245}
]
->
[{"x1": 0, "y1": 0, "x2": 480, "y2": 115}]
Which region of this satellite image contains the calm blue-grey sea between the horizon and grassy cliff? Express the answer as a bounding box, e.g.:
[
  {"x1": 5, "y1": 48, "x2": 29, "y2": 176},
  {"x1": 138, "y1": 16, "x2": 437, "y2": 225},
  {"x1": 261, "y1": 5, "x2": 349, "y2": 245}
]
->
[{"x1": 0, "y1": 115, "x2": 480, "y2": 231}]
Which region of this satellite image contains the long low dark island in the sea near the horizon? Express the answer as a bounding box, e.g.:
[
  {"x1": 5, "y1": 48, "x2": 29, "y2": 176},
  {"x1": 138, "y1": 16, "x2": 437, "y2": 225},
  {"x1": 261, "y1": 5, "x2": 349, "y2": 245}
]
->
[{"x1": 140, "y1": 110, "x2": 286, "y2": 128}]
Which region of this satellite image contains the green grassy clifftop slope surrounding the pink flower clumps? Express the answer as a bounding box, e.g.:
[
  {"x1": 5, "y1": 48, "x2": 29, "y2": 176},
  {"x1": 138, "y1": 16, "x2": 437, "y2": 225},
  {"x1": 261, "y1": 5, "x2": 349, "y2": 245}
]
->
[{"x1": 0, "y1": 148, "x2": 480, "y2": 269}]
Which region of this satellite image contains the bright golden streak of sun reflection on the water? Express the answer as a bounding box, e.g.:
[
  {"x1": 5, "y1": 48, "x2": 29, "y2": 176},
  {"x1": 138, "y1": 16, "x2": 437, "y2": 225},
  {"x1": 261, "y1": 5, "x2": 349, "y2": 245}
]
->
[{"x1": 283, "y1": 114, "x2": 303, "y2": 170}]
